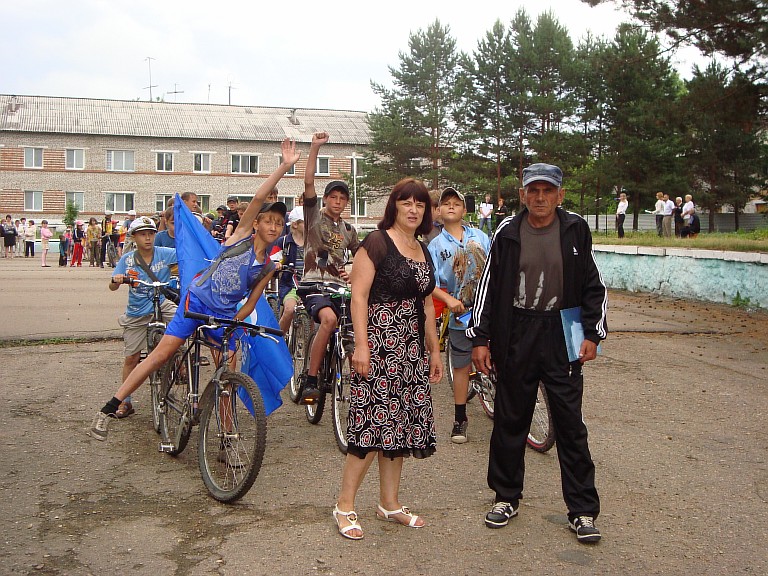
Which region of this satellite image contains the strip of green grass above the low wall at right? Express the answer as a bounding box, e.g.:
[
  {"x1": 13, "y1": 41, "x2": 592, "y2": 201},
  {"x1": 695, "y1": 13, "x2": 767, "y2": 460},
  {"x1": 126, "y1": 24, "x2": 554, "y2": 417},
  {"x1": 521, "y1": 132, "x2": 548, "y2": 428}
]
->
[{"x1": 592, "y1": 228, "x2": 768, "y2": 252}]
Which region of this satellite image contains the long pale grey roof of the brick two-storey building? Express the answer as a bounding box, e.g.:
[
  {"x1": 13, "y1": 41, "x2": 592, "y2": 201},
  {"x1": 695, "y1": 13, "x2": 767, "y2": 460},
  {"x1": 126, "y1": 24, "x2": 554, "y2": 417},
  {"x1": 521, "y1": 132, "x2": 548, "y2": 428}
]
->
[{"x1": 0, "y1": 94, "x2": 370, "y2": 145}]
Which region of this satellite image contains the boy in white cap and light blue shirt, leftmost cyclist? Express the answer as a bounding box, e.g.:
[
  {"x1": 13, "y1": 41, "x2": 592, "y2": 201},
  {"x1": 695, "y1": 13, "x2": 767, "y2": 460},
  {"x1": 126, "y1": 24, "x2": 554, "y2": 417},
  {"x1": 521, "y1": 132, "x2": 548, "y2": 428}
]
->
[{"x1": 109, "y1": 216, "x2": 178, "y2": 418}]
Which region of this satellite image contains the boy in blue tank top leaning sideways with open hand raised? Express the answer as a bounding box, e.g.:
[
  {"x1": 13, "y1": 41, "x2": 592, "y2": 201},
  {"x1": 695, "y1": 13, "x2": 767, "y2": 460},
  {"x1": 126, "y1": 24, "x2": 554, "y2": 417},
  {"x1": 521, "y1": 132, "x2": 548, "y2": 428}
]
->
[{"x1": 88, "y1": 138, "x2": 301, "y2": 440}]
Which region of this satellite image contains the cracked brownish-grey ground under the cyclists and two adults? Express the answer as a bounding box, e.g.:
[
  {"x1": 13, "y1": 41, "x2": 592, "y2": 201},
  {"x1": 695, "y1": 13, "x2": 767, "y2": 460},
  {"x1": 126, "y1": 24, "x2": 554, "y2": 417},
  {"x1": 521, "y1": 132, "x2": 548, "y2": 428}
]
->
[{"x1": 0, "y1": 259, "x2": 768, "y2": 576}]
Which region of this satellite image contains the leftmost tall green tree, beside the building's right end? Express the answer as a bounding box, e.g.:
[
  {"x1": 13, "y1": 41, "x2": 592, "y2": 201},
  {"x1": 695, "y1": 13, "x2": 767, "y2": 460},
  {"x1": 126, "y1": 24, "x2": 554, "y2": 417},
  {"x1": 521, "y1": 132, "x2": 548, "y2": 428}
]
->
[{"x1": 366, "y1": 20, "x2": 463, "y2": 188}]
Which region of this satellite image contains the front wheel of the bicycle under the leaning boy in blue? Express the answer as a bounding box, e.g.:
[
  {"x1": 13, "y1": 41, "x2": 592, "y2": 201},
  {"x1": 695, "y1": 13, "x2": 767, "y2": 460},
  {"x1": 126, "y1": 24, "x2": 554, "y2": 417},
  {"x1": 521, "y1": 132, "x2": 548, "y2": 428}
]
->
[{"x1": 197, "y1": 371, "x2": 267, "y2": 502}]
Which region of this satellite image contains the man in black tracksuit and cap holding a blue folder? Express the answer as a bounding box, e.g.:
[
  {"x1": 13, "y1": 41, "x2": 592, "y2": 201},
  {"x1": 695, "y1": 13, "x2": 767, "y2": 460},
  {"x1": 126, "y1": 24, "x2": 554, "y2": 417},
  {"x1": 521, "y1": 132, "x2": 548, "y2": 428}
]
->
[{"x1": 467, "y1": 164, "x2": 608, "y2": 542}]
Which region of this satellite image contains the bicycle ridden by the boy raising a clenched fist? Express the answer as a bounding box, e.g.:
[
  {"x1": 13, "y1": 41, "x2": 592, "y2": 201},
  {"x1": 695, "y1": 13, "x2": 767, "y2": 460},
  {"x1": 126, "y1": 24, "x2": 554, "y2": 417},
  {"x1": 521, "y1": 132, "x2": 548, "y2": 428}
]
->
[{"x1": 299, "y1": 282, "x2": 355, "y2": 454}]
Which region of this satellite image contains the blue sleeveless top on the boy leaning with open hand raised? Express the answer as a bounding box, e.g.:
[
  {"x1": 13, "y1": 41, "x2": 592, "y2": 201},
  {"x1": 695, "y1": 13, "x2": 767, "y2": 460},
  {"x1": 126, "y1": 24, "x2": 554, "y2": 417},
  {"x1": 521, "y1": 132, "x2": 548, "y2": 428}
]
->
[{"x1": 189, "y1": 236, "x2": 264, "y2": 318}]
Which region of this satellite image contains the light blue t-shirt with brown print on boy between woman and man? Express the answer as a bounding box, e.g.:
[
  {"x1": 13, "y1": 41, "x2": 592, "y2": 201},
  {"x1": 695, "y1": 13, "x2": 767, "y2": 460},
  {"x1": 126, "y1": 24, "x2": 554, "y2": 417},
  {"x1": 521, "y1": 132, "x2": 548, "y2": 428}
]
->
[{"x1": 428, "y1": 226, "x2": 491, "y2": 330}]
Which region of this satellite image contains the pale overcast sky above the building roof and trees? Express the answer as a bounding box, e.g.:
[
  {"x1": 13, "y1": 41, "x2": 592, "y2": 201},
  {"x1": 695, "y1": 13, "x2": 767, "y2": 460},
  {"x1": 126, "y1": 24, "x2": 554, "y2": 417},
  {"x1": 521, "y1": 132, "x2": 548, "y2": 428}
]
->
[{"x1": 0, "y1": 0, "x2": 708, "y2": 111}]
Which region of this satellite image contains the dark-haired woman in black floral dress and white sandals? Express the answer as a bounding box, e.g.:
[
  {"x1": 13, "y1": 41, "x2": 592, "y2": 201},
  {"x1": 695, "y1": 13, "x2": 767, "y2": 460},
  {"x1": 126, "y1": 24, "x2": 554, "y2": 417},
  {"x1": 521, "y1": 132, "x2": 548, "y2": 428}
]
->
[{"x1": 333, "y1": 178, "x2": 443, "y2": 540}]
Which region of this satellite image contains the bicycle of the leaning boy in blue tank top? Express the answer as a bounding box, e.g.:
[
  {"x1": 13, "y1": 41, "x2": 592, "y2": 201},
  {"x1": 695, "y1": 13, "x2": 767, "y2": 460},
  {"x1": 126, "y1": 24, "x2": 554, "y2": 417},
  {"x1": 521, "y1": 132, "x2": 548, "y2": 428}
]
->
[{"x1": 159, "y1": 311, "x2": 283, "y2": 502}]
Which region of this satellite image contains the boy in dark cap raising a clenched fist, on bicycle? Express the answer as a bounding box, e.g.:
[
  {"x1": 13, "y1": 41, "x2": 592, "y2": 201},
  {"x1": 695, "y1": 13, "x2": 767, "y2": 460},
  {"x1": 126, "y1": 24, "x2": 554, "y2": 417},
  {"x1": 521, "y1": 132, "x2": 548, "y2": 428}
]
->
[{"x1": 299, "y1": 132, "x2": 360, "y2": 404}]
